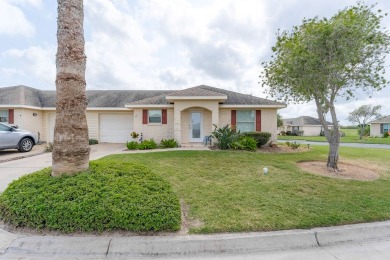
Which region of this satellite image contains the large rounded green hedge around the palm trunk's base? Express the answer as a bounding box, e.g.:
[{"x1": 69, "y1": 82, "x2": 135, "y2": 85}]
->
[{"x1": 0, "y1": 160, "x2": 181, "y2": 232}]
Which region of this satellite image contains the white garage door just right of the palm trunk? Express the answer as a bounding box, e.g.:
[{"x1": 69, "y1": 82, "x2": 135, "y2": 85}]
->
[{"x1": 99, "y1": 113, "x2": 133, "y2": 143}]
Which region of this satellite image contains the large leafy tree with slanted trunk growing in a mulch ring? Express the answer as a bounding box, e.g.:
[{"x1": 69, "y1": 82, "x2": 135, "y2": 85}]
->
[{"x1": 260, "y1": 3, "x2": 390, "y2": 171}]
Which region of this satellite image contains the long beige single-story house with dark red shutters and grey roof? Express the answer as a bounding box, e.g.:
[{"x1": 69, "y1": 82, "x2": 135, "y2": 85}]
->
[{"x1": 0, "y1": 85, "x2": 286, "y2": 145}]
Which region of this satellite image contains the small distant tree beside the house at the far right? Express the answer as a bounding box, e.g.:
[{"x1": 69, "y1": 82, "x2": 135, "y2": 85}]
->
[{"x1": 347, "y1": 105, "x2": 382, "y2": 140}]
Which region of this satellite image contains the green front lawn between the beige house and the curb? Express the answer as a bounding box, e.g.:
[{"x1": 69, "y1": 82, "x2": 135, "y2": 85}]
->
[{"x1": 101, "y1": 146, "x2": 390, "y2": 233}]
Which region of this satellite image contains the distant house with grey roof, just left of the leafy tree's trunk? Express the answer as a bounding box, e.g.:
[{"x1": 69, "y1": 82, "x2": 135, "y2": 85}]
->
[{"x1": 279, "y1": 116, "x2": 333, "y2": 136}]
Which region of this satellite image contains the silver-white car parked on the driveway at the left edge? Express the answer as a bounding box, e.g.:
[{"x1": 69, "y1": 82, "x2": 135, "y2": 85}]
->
[{"x1": 0, "y1": 123, "x2": 38, "y2": 152}]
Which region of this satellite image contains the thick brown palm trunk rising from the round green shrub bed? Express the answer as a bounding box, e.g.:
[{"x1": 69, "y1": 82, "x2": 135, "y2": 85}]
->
[{"x1": 52, "y1": 0, "x2": 90, "y2": 176}]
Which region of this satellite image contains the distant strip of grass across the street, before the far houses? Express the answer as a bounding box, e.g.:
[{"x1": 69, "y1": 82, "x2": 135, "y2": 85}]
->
[{"x1": 278, "y1": 128, "x2": 390, "y2": 144}]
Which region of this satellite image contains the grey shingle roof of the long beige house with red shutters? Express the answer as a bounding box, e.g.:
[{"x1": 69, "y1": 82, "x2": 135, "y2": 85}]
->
[{"x1": 0, "y1": 85, "x2": 285, "y2": 108}]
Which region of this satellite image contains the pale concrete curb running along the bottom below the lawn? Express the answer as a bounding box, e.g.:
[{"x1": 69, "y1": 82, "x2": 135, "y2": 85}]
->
[{"x1": 0, "y1": 221, "x2": 390, "y2": 257}]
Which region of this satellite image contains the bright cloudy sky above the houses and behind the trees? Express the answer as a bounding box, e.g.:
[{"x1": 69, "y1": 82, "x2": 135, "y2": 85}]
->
[{"x1": 0, "y1": 0, "x2": 390, "y2": 125}]
